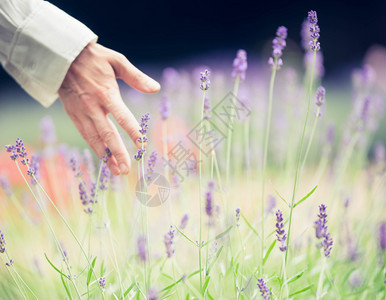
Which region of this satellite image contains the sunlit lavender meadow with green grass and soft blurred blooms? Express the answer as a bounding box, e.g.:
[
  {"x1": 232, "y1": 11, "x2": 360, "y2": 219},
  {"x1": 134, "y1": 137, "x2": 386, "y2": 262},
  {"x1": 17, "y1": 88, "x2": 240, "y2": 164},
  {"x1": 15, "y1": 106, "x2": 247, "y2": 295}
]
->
[{"x1": 0, "y1": 9, "x2": 386, "y2": 299}]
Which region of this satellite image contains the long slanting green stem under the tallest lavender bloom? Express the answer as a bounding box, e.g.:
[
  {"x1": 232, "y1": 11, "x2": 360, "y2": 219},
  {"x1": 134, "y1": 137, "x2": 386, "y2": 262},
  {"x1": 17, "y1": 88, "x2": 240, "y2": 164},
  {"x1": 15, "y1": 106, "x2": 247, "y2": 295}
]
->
[{"x1": 285, "y1": 50, "x2": 316, "y2": 267}]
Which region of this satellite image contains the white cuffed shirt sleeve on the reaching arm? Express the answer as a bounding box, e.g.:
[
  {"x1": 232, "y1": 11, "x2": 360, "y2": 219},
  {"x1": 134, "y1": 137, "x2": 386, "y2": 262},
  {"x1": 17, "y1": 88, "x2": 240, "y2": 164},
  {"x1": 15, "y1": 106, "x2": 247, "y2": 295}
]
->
[{"x1": 0, "y1": 0, "x2": 97, "y2": 107}]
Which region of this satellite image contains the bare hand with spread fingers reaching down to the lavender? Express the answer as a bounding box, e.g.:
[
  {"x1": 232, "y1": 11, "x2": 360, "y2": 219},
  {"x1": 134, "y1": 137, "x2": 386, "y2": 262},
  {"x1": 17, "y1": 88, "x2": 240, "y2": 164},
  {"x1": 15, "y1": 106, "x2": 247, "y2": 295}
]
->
[{"x1": 59, "y1": 43, "x2": 160, "y2": 175}]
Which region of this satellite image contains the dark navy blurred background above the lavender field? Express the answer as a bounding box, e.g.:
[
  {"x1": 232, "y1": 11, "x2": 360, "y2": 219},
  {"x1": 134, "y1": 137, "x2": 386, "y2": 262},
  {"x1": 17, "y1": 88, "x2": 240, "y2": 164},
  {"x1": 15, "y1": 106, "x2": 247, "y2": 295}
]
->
[{"x1": 0, "y1": 0, "x2": 386, "y2": 86}]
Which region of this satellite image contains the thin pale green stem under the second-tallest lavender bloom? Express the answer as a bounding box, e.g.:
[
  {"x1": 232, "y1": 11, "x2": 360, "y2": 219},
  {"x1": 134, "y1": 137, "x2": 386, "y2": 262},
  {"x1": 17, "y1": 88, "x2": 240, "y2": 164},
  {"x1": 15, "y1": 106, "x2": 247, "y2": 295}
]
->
[{"x1": 260, "y1": 57, "x2": 277, "y2": 273}]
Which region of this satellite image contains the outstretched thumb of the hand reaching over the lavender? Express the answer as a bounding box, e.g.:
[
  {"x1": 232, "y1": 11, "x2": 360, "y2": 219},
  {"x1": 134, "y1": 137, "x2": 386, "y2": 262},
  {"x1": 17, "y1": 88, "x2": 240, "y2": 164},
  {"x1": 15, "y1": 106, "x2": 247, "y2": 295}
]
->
[{"x1": 109, "y1": 51, "x2": 161, "y2": 93}]
